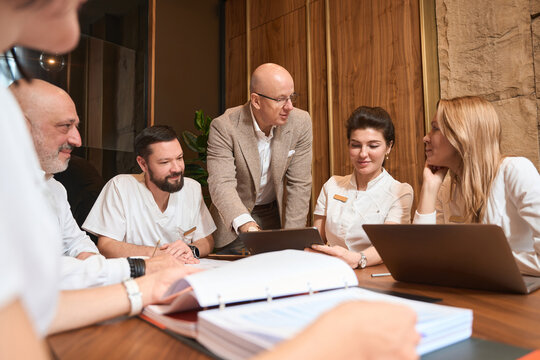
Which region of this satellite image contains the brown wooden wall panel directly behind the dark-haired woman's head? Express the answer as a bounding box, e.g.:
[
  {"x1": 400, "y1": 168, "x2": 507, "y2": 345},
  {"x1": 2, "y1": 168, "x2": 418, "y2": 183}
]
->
[{"x1": 331, "y1": 0, "x2": 424, "y2": 202}]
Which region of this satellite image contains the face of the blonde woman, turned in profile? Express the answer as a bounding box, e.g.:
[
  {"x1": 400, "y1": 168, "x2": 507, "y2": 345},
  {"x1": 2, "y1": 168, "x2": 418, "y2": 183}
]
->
[{"x1": 424, "y1": 112, "x2": 461, "y2": 172}]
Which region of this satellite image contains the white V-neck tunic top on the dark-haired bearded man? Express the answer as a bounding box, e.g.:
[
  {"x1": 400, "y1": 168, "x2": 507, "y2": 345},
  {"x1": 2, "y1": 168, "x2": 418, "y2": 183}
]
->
[{"x1": 82, "y1": 174, "x2": 216, "y2": 246}]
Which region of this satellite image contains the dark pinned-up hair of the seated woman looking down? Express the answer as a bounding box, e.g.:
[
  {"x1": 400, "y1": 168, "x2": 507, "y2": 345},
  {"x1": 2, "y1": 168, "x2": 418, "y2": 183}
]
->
[{"x1": 345, "y1": 106, "x2": 395, "y2": 146}]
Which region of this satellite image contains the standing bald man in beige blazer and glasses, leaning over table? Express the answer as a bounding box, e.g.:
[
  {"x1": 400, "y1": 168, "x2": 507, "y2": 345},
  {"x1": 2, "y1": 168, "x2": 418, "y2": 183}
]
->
[{"x1": 207, "y1": 64, "x2": 313, "y2": 254}]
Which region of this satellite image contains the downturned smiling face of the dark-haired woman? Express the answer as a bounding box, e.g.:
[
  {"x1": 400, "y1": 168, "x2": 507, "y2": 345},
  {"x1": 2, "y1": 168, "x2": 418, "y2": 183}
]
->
[{"x1": 349, "y1": 128, "x2": 392, "y2": 183}]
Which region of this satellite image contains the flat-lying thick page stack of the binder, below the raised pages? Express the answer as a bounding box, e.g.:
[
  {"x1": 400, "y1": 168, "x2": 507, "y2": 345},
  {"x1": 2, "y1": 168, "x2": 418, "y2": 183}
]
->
[{"x1": 197, "y1": 288, "x2": 473, "y2": 359}]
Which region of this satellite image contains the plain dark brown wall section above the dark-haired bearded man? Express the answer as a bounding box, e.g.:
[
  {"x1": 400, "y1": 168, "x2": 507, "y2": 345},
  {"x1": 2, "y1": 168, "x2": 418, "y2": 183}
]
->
[{"x1": 154, "y1": 0, "x2": 220, "y2": 143}]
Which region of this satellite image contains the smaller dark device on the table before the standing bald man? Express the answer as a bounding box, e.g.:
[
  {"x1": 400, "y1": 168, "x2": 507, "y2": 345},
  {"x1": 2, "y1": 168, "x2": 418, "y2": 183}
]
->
[{"x1": 238, "y1": 227, "x2": 324, "y2": 255}]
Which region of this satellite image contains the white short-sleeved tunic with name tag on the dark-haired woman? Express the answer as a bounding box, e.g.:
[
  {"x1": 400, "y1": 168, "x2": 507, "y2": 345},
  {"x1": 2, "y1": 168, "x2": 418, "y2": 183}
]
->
[{"x1": 313, "y1": 169, "x2": 413, "y2": 251}]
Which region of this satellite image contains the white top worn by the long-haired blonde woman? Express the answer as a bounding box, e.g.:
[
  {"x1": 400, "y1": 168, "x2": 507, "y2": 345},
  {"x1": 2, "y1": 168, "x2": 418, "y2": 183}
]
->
[{"x1": 414, "y1": 157, "x2": 540, "y2": 276}]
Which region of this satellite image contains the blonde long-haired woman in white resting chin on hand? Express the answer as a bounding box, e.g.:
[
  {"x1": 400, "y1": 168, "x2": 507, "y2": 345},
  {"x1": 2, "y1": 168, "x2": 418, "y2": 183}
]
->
[{"x1": 414, "y1": 96, "x2": 540, "y2": 276}]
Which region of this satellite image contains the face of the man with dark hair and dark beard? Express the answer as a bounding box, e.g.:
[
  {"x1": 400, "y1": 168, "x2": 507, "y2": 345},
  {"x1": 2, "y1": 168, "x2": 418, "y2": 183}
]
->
[{"x1": 137, "y1": 139, "x2": 185, "y2": 193}]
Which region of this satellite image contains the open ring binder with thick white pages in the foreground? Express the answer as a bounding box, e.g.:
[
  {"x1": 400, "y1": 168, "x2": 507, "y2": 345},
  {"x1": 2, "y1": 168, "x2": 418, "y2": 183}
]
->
[{"x1": 143, "y1": 250, "x2": 472, "y2": 359}]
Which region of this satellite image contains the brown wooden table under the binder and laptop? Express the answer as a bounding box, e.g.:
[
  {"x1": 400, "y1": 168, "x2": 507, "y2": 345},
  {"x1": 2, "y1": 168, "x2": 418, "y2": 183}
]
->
[{"x1": 47, "y1": 265, "x2": 540, "y2": 360}]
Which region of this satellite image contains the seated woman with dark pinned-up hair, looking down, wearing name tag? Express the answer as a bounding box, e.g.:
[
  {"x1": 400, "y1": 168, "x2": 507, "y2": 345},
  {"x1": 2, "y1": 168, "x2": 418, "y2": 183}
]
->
[{"x1": 313, "y1": 106, "x2": 413, "y2": 269}]
